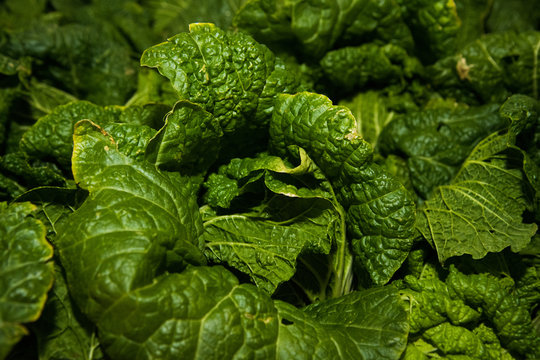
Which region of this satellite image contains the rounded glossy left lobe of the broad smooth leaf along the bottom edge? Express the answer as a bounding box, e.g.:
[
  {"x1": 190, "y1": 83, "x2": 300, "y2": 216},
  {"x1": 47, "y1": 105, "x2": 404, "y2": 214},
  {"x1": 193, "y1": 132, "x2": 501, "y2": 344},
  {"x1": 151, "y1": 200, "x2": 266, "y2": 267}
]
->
[{"x1": 98, "y1": 267, "x2": 279, "y2": 360}]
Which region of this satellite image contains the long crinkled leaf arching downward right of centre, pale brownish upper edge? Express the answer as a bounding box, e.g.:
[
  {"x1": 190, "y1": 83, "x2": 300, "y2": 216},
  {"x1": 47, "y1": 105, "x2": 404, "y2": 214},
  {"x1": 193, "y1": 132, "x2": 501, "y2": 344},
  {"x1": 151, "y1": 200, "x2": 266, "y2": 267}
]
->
[{"x1": 270, "y1": 92, "x2": 415, "y2": 284}]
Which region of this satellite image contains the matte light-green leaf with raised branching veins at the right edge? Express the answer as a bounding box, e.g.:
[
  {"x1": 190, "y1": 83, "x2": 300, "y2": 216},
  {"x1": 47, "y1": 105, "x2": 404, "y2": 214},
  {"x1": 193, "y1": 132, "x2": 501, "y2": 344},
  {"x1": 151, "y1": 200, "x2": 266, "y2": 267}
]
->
[{"x1": 418, "y1": 133, "x2": 537, "y2": 261}]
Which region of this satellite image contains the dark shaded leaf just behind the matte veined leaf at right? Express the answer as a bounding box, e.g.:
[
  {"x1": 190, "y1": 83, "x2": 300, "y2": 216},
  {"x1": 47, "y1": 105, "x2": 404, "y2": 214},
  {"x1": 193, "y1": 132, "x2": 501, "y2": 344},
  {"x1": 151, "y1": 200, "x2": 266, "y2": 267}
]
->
[{"x1": 379, "y1": 105, "x2": 508, "y2": 198}]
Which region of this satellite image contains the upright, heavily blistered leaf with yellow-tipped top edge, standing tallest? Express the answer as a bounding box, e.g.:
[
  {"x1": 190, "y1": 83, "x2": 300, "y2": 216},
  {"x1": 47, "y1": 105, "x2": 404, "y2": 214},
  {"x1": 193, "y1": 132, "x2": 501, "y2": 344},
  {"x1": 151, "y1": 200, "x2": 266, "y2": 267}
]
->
[{"x1": 141, "y1": 23, "x2": 306, "y2": 156}]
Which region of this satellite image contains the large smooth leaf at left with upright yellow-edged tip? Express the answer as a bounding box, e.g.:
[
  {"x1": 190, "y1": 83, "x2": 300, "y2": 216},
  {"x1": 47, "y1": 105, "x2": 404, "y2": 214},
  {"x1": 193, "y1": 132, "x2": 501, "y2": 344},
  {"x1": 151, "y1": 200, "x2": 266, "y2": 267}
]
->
[{"x1": 55, "y1": 121, "x2": 204, "y2": 321}]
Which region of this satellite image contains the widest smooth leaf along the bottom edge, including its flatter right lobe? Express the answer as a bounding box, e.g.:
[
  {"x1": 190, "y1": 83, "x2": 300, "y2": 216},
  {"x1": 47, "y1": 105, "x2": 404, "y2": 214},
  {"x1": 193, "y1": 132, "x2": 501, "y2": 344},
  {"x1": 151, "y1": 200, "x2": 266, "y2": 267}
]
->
[{"x1": 100, "y1": 267, "x2": 408, "y2": 360}]
